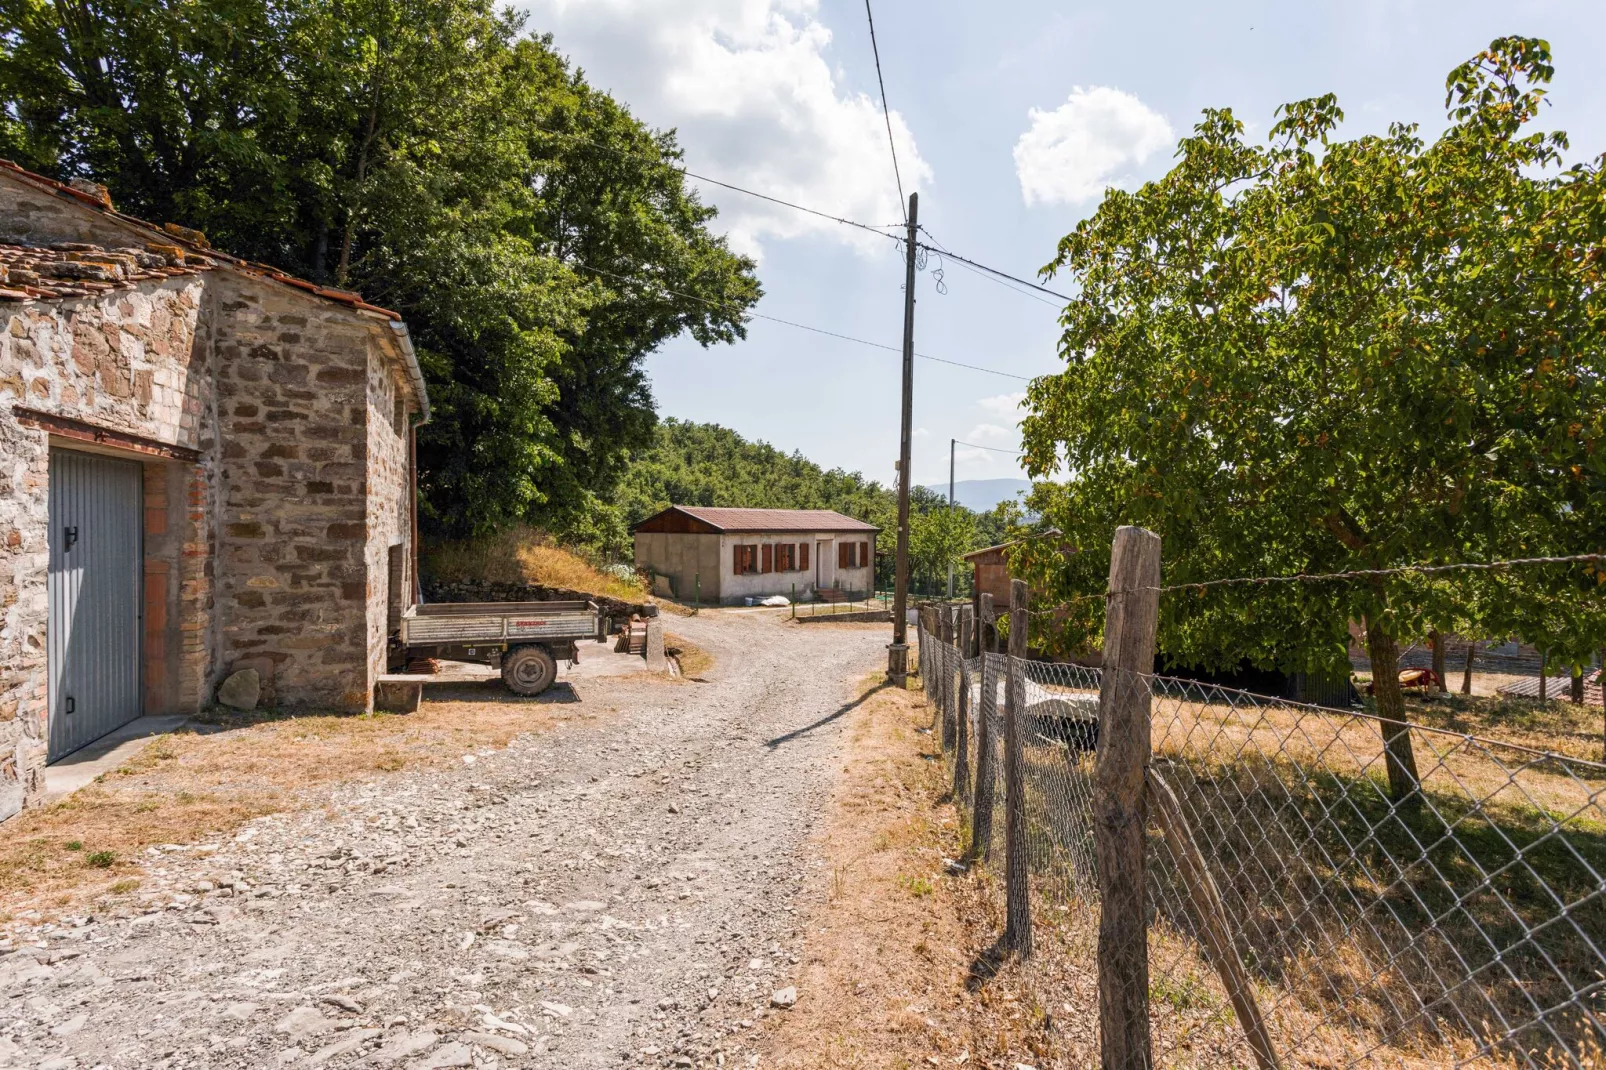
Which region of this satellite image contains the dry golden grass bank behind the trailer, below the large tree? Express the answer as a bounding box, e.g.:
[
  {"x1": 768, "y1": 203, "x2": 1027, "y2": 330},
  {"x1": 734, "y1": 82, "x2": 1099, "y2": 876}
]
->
[{"x1": 424, "y1": 525, "x2": 647, "y2": 602}]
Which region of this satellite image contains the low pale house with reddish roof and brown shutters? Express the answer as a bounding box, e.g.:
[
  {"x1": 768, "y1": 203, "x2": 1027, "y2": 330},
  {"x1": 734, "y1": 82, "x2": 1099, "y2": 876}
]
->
[{"x1": 633, "y1": 506, "x2": 880, "y2": 606}]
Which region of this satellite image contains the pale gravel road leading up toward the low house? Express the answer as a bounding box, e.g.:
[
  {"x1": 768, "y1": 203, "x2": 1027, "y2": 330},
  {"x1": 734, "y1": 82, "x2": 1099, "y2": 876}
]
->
[{"x1": 0, "y1": 614, "x2": 887, "y2": 1070}]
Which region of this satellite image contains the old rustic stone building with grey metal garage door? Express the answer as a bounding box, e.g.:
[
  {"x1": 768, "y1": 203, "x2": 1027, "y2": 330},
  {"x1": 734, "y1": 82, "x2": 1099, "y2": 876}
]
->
[{"x1": 0, "y1": 161, "x2": 429, "y2": 819}]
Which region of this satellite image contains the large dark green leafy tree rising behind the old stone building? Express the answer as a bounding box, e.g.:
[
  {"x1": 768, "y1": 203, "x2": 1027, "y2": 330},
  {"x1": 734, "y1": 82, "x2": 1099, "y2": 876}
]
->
[{"x1": 0, "y1": 0, "x2": 760, "y2": 540}]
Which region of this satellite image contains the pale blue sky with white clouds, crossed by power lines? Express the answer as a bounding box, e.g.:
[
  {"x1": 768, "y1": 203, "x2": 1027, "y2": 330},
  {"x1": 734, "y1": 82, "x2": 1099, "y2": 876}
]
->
[{"x1": 524, "y1": 0, "x2": 1606, "y2": 484}]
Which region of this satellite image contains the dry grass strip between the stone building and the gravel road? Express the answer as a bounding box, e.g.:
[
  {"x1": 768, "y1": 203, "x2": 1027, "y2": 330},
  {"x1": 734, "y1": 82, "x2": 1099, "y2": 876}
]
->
[{"x1": 0, "y1": 692, "x2": 574, "y2": 919}]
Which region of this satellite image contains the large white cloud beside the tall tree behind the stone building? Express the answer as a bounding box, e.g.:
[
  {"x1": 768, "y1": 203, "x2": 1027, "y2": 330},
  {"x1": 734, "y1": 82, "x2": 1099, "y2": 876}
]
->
[{"x1": 522, "y1": 0, "x2": 931, "y2": 255}]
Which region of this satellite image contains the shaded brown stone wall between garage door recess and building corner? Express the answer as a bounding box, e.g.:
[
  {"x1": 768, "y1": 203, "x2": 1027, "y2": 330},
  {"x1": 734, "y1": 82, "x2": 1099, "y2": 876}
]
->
[{"x1": 212, "y1": 272, "x2": 373, "y2": 710}]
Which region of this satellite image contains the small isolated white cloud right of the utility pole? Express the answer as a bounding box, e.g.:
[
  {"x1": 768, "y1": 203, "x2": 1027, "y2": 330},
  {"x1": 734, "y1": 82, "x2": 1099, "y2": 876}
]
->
[{"x1": 1015, "y1": 85, "x2": 1176, "y2": 206}]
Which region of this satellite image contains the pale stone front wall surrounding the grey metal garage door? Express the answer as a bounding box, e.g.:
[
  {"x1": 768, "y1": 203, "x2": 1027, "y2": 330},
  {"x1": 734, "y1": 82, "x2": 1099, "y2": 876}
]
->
[{"x1": 0, "y1": 273, "x2": 215, "y2": 818}]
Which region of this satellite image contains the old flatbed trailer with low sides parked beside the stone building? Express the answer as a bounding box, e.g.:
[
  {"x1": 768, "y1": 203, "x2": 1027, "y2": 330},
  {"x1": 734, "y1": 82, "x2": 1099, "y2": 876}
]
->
[{"x1": 397, "y1": 602, "x2": 604, "y2": 696}]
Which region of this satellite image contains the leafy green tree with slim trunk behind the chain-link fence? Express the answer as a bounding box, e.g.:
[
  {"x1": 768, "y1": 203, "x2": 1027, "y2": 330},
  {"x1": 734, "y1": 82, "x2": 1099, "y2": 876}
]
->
[{"x1": 1025, "y1": 37, "x2": 1606, "y2": 797}]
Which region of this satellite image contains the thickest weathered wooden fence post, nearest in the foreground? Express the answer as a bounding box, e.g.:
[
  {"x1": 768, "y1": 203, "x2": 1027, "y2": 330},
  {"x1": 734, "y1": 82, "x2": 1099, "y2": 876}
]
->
[{"x1": 1098, "y1": 527, "x2": 1160, "y2": 1070}]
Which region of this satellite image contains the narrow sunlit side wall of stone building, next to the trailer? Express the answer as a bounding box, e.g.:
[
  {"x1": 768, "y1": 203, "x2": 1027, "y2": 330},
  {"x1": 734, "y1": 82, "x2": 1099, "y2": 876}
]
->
[{"x1": 363, "y1": 342, "x2": 413, "y2": 694}]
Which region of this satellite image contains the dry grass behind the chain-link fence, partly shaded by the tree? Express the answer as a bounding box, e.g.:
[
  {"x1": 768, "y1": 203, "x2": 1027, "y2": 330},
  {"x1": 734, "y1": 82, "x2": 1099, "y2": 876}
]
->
[{"x1": 983, "y1": 674, "x2": 1606, "y2": 1067}]
